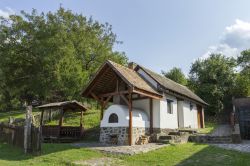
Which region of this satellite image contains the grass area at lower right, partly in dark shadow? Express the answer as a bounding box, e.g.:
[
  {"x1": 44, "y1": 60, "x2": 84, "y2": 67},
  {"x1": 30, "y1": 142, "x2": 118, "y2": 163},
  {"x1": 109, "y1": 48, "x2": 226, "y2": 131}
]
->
[{"x1": 121, "y1": 143, "x2": 250, "y2": 166}]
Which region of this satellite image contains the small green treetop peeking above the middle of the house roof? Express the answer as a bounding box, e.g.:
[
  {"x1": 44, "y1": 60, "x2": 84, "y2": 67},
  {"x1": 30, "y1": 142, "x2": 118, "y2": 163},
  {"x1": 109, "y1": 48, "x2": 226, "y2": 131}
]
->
[{"x1": 162, "y1": 67, "x2": 187, "y2": 85}]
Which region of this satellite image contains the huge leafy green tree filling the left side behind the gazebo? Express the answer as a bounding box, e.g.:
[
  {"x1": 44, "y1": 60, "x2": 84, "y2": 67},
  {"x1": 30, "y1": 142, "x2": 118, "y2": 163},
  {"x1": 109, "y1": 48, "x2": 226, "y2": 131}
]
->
[{"x1": 0, "y1": 7, "x2": 127, "y2": 110}]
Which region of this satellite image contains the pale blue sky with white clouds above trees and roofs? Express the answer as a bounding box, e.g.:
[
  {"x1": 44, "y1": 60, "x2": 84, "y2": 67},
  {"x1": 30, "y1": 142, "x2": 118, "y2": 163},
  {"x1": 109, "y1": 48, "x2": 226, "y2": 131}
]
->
[{"x1": 0, "y1": 0, "x2": 250, "y2": 75}]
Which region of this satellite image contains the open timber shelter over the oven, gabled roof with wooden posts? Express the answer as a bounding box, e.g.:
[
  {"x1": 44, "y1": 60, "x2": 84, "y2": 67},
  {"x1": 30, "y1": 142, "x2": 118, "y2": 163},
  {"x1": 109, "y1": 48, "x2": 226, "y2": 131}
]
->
[{"x1": 82, "y1": 61, "x2": 162, "y2": 145}]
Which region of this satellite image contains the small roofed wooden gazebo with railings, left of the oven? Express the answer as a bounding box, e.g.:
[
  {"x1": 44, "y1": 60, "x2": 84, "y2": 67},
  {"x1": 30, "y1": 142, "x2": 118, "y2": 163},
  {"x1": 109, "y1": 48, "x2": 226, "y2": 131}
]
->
[{"x1": 37, "y1": 101, "x2": 87, "y2": 140}]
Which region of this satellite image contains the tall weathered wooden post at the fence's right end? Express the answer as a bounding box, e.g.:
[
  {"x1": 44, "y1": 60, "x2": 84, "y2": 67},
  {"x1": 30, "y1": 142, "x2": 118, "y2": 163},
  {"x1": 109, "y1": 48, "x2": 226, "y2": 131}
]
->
[{"x1": 24, "y1": 106, "x2": 32, "y2": 154}]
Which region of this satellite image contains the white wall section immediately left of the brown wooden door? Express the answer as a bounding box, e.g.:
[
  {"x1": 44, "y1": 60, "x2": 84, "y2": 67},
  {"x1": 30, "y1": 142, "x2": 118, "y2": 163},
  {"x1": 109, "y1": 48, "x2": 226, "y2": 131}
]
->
[{"x1": 183, "y1": 100, "x2": 198, "y2": 128}]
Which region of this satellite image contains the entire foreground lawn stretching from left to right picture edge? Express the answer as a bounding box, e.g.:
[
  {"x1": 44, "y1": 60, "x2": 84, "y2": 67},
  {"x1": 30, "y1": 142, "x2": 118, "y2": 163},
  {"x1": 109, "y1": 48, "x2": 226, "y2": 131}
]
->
[{"x1": 0, "y1": 143, "x2": 250, "y2": 166}]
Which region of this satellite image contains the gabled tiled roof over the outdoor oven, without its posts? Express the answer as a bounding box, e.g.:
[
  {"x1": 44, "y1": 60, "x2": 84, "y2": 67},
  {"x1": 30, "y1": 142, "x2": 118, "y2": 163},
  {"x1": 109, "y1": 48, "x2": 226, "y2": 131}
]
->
[{"x1": 82, "y1": 61, "x2": 162, "y2": 97}]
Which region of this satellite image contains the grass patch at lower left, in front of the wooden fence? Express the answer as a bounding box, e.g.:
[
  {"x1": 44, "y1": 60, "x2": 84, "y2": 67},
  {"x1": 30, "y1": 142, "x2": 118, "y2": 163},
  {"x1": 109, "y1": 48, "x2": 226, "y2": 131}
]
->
[{"x1": 0, "y1": 143, "x2": 103, "y2": 166}]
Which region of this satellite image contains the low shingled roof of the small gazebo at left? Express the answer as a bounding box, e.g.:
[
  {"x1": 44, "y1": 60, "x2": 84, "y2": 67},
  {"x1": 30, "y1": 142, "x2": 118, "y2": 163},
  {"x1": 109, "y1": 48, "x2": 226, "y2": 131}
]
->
[{"x1": 37, "y1": 100, "x2": 87, "y2": 111}]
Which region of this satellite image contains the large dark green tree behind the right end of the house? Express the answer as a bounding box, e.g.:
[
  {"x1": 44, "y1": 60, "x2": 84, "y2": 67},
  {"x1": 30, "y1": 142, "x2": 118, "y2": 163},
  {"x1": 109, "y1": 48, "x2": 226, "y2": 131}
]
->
[{"x1": 189, "y1": 54, "x2": 236, "y2": 115}]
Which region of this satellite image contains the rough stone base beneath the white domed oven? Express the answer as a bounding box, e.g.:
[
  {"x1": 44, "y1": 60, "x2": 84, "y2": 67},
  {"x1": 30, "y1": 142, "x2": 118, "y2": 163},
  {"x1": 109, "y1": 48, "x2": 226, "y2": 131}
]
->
[{"x1": 100, "y1": 127, "x2": 149, "y2": 145}]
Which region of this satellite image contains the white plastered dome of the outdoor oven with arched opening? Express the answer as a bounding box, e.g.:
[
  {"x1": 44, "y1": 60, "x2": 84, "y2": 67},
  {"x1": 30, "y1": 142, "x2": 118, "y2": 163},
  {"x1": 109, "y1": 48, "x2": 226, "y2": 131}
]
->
[{"x1": 100, "y1": 105, "x2": 149, "y2": 127}]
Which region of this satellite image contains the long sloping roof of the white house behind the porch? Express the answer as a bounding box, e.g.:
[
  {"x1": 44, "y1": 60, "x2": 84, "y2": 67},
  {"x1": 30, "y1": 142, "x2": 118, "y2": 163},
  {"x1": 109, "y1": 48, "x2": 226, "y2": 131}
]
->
[{"x1": 135, "y1": 65, "x2": 208, "y2": 105}]
